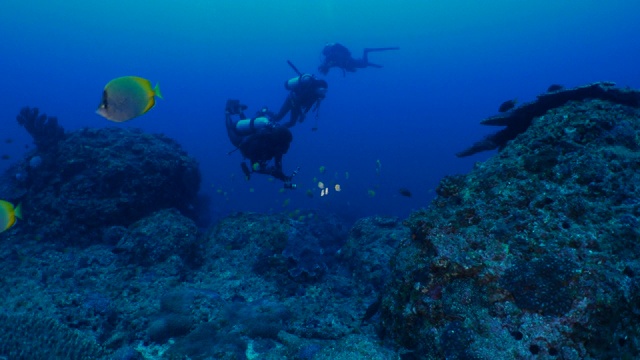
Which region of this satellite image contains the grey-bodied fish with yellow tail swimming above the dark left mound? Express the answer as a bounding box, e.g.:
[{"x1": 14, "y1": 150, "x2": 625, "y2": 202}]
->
[{"x1": 96, "y1": 76, "x2": 162, "y2": 122}]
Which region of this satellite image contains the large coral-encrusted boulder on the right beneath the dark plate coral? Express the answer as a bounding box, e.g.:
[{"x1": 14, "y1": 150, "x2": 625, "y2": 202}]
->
[{"x1": 380, "y1": 97, "x2": 640, "y2": 359}]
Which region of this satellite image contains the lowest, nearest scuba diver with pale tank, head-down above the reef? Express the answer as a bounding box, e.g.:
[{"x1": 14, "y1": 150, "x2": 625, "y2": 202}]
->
[{"x1": 225, "y1": 100, "x2": 298, "y2": 189}]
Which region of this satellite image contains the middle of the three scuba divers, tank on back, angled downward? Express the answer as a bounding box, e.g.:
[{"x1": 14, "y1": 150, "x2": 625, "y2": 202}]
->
[{"x1": 272, "y1": 70, "x2": 328, "y2": 130}]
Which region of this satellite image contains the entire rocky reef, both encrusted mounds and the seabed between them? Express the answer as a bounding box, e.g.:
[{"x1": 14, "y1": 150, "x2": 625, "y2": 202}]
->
[{"x1": 5, "y1": 91, "x2": 640, "y2": 360}]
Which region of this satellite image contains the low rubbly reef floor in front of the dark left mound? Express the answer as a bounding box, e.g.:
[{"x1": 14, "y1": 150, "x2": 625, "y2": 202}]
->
[{"x1": 0, "y1": 209, "x2": 402, "y2": 360}]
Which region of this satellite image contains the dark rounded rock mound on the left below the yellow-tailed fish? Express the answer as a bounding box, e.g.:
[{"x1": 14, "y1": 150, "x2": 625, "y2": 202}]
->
[{"x1": 6, "y1": 119, "x2": 201, "y2": 245}]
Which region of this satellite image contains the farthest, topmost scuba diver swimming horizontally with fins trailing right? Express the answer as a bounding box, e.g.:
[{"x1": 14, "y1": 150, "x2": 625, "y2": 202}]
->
[{"x1": 318, "y1": 43, "x2": 400, "y2": 76}]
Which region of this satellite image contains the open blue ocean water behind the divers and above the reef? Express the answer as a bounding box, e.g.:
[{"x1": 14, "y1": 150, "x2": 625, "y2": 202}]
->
[{"x1": 0, "y1": 0, "x2": 640, "y2": 222}]
